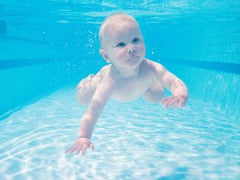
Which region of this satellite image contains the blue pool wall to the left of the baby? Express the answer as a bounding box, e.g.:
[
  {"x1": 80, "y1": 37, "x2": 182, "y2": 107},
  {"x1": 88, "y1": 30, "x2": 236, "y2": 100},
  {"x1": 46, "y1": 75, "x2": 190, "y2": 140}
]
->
[{"x1": 0, "y1": 24, "x2": 103, "y2": 119}]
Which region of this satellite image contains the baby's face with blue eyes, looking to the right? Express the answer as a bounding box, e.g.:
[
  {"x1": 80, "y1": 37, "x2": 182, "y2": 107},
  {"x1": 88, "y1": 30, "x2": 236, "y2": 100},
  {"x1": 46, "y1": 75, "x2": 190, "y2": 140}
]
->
[{"x1": 103, "y1": 21, "x2": 146, "y2": 69}]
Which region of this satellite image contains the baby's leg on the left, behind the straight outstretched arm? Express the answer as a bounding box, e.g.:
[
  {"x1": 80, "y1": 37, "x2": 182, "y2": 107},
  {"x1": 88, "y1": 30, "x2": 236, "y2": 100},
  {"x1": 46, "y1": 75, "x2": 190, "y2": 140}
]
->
[{"x1": 77, "y1": 73, "x2": 102, "y2": 105}]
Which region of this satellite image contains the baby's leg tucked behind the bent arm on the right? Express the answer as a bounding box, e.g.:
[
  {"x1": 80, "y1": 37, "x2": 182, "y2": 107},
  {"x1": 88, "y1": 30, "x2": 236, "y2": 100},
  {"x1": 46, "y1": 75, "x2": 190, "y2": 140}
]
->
[{"x1": 143, "y1": 83, "x2": 164, "y2": 103}]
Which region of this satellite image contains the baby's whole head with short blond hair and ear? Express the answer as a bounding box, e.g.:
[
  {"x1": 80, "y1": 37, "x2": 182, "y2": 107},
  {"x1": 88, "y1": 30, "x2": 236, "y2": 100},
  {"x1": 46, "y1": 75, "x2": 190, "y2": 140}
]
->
[{"x1": 99, "y1": 13, "x2": 145, "y2": 68}]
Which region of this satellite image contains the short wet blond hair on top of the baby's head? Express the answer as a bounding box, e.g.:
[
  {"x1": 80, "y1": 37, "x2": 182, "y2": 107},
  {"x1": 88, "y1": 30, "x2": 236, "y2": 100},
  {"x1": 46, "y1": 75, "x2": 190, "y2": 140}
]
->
[{"x1": 99, "y1": 13, "x2": 138, "y2": 48}]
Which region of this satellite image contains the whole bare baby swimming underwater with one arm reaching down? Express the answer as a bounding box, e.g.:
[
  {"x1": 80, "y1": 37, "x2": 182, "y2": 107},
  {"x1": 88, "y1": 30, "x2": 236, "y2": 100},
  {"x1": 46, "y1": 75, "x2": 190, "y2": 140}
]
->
[{"x1": 66, "y1": 13, "x2": 188, "y2": 155}]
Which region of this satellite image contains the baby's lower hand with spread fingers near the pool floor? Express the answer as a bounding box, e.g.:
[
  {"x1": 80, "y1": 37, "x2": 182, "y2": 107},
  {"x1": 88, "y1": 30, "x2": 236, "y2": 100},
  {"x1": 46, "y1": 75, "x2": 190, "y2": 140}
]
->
[{"x1": 65, "y1": 137, "x2": 94, "y2": 155}]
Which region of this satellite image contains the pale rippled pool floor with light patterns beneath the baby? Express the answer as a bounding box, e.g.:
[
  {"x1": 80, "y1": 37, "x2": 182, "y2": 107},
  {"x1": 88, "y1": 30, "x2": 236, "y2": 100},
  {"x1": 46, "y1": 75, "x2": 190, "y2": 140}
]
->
[{"x1": 0, "y1": 87, "x2": 240, "y2": 180}]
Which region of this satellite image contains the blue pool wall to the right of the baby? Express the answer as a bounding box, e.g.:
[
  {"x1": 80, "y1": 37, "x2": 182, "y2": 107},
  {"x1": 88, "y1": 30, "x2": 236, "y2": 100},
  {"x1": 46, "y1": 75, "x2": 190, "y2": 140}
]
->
[{"x1": 142, "y1": 14, "x2": 240, "y2": 119}]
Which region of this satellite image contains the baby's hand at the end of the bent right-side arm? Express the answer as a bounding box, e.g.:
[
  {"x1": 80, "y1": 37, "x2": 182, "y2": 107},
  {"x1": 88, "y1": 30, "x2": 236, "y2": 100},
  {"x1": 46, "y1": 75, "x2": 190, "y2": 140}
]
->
[{"x1": 162, "y1": 96, "x2": 187, "y2": 108}]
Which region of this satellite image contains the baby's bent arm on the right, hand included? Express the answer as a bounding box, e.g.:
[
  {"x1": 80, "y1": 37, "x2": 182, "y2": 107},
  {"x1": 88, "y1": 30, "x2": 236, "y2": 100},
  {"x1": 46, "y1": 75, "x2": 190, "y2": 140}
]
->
[{"x1": 154, "y1": 63, "x2": 188, "y2": 108}]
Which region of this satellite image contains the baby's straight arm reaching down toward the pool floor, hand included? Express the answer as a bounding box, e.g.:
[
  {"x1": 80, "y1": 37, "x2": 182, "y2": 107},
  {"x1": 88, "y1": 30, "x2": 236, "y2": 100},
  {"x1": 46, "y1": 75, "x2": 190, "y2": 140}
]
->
[{"x1": 66, "y1": 78, "x2": 113, "y2": 155}]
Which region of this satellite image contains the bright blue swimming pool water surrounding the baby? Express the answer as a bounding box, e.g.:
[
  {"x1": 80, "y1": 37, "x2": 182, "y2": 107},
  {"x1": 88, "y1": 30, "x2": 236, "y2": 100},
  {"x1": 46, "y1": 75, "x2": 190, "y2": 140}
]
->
[{"x1": 0, "y1": 0, "x2": 240, "y2": 180}]
